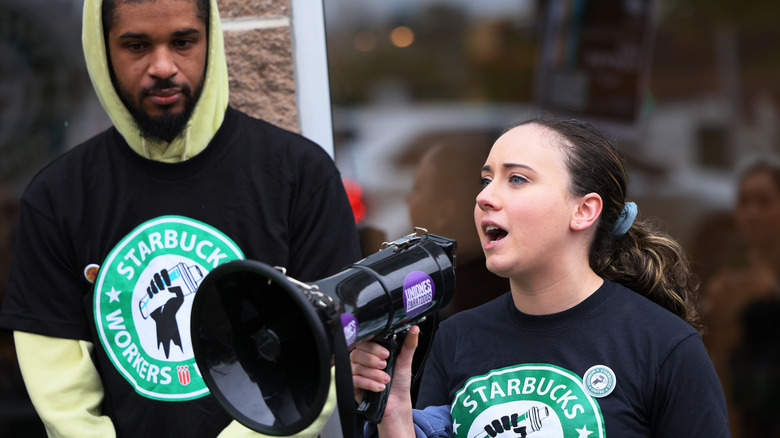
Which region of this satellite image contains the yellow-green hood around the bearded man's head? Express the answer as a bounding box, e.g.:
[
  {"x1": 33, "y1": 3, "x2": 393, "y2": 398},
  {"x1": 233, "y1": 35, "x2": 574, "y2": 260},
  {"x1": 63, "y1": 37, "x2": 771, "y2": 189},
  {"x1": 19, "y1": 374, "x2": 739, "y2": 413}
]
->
[{"x1": 81, "y1": 0, "x2": 229, "y2": 163}]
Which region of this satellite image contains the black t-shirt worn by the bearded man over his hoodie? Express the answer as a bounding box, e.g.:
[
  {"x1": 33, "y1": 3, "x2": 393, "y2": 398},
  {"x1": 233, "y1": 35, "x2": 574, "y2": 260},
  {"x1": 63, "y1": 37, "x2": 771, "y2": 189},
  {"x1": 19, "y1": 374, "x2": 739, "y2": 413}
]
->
[{"x1": 0, "y1": 109, "x2": 360, "y2": 437}]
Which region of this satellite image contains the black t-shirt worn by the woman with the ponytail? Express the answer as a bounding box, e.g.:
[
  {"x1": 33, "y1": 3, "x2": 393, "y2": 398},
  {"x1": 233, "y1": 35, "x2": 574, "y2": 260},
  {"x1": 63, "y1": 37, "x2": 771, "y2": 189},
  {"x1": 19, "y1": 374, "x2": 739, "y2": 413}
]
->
[{"x1": 417, "y1": 281, "x2": 729, "y2": 438}]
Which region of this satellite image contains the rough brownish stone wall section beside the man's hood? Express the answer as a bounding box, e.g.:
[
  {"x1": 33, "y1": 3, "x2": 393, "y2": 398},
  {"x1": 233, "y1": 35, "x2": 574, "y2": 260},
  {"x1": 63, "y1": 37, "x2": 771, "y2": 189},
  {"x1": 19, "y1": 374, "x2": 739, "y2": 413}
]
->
[{"x1": 218, "y1": 0, "x2": 298, "y2": 132}]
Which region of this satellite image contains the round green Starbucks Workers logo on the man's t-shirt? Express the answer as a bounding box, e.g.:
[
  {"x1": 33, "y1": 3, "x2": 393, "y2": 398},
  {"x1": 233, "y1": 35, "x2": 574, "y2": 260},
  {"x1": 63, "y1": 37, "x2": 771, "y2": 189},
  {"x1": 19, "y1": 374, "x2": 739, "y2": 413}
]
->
[{"x1": 94, "y1": 216, "x2": 244, "y2": 401}]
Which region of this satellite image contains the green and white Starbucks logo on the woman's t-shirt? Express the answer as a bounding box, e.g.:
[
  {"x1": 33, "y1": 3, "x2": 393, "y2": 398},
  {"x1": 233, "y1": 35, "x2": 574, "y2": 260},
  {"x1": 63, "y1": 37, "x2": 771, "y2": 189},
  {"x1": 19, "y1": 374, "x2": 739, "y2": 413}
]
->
[{"x1": 452, "y1": 364, "x2": 606, "y2": 438}]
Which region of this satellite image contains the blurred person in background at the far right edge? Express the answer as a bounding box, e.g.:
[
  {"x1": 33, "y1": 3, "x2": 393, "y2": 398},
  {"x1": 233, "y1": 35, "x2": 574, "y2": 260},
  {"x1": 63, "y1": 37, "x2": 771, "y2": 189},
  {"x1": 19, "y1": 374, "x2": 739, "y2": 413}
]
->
[{"x1": 702, "y1": 158, "x2": 780, "y2": 437}]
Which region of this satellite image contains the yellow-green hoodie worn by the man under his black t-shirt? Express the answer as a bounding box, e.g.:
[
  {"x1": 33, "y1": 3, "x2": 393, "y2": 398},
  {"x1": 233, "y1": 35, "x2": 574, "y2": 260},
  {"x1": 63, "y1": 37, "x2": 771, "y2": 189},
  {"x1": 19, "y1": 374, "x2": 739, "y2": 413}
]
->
[{"x1": 14, "y1": 0, "x2": 336, "y2": 438}]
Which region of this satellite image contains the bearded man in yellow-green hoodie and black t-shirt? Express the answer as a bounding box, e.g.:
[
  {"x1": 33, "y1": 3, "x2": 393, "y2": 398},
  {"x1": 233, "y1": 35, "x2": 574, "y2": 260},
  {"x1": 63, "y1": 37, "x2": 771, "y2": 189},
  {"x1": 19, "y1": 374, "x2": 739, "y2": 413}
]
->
[{"x1": 0, "y1": 0, "x2": 360, "y2": 438}]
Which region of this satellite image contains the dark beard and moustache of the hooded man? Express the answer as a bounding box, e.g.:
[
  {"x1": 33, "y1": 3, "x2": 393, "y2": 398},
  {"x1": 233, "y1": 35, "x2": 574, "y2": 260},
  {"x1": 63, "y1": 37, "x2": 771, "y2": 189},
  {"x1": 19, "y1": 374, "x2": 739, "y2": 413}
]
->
[{"x1": 117, "y1": 79, "x2": 201, "y2": 143}]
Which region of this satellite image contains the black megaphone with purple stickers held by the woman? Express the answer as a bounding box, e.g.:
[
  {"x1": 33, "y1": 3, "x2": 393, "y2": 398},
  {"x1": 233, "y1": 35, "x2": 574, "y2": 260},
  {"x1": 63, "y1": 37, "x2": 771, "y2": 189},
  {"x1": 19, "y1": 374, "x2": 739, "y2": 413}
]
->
[{"x1": 191, "y1": 229, "x2": 456, "y2": 436}]
